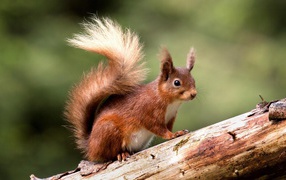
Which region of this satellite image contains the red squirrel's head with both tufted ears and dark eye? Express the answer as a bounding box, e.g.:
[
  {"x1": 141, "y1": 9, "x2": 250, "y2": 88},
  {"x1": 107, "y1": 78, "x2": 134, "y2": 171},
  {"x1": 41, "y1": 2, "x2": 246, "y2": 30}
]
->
[{"x1": 159, "y1": 48, "x2": 197, "y2": 101}]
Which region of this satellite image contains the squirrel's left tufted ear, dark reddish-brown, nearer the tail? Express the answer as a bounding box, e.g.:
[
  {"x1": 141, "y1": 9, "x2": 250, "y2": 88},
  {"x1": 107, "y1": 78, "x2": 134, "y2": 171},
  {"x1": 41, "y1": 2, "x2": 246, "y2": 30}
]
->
[{"x1": 161, "y1": 48, "x2": 174, "y2": 81}]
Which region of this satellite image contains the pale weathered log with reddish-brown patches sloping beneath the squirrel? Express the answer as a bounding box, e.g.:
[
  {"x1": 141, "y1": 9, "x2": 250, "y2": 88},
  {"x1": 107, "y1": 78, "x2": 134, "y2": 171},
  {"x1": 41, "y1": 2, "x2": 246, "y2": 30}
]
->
[{"x1": 31, "y1": 100, "x2": 286, "y2": 180}]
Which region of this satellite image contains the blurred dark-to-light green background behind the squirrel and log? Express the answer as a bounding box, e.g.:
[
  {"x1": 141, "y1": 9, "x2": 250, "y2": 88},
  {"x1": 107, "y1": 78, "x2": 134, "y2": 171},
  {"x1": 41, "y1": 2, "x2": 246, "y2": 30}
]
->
[{"x1": 0, "y1": 0, "x2": 286, "y2": 179}]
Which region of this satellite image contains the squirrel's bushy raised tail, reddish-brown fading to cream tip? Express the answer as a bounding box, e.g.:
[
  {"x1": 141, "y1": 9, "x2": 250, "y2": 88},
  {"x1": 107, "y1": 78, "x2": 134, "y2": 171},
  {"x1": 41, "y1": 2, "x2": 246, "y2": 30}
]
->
[{"x1": 65, "y1": 17, "x2": 147, "y2": 151}]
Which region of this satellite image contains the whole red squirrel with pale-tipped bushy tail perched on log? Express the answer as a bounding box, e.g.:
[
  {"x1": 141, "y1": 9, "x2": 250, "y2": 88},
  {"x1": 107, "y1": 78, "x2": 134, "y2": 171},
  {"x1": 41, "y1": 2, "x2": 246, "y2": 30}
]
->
[{"x1": 65, "y1": 17, "x2": 197, "y2": 162}]
